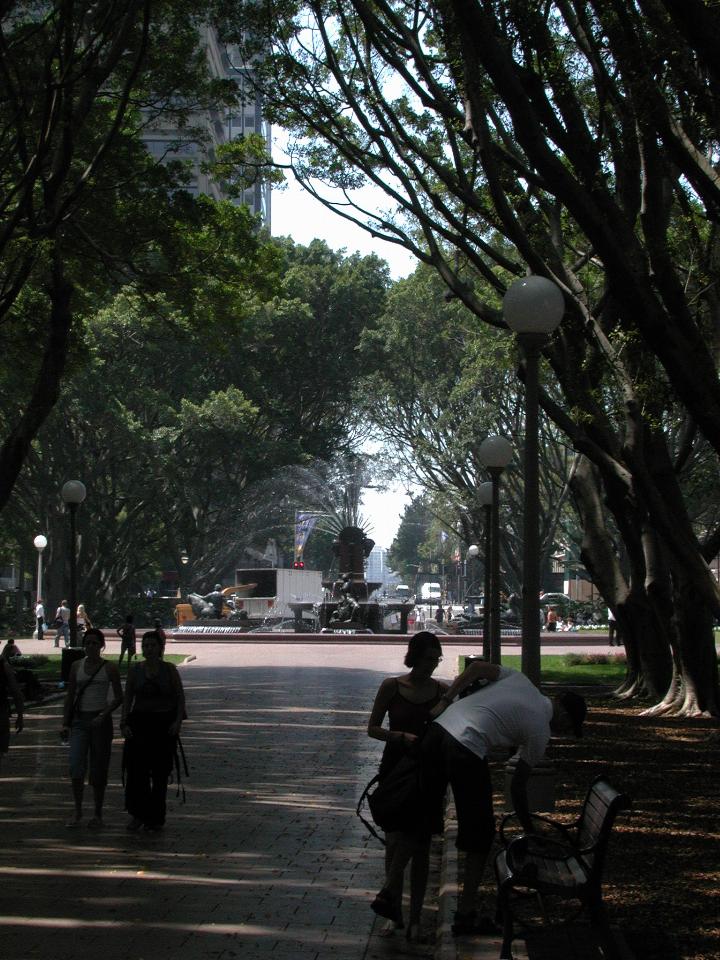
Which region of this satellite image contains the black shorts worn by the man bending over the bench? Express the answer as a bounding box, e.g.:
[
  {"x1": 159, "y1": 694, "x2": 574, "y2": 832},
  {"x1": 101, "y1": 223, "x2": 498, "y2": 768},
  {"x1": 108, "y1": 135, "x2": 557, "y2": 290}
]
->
[{"x1": 422, "y1": 723, "x2": 495, "y2": 854}]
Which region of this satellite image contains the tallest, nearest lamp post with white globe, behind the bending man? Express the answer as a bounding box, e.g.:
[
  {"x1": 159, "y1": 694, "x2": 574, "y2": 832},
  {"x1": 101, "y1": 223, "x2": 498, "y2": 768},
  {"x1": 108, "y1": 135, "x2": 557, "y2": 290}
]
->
[{"x1": 503, "y1": 276, "x2": 565, "y2": 685}]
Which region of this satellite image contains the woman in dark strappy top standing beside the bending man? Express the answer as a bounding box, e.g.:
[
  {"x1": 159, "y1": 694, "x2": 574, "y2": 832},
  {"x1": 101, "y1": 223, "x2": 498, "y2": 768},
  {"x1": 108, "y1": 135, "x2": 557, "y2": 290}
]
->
[{"x1": 368, "y1": 630, "x2": 448, "y2": 940}]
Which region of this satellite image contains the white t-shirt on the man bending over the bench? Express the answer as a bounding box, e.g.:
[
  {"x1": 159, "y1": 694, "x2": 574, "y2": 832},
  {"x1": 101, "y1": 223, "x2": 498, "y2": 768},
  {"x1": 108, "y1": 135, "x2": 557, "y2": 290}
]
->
[{"x1": 435, "y1": 667, "x2": 552, "y2": 767}]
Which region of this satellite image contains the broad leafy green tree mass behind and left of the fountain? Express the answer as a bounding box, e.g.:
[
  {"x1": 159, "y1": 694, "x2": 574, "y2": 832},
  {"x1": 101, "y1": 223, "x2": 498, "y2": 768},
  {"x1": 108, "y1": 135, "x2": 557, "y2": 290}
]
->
[{"x1": 5, "y1": 236, "x2": 387, "y2": 604}]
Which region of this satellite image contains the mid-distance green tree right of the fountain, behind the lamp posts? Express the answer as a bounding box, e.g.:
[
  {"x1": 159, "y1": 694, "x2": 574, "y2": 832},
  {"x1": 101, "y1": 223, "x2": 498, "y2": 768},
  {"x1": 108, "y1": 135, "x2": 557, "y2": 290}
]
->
[{"x1": 362, "y1": 266, "x2": 574, "y2": 592}]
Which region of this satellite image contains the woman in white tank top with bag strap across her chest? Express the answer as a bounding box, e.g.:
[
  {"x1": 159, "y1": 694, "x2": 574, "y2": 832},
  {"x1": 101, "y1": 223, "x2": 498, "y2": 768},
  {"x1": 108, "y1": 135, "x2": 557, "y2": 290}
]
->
[{"x1": 60, "y1": 628, "x2": 122, "y2": 827}]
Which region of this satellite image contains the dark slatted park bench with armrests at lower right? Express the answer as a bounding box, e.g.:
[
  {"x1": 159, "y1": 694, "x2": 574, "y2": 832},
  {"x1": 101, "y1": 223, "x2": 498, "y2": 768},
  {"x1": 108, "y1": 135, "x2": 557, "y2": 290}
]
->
[{"x1": 495, "y1": 777, "x2": 630, "y2": 960}]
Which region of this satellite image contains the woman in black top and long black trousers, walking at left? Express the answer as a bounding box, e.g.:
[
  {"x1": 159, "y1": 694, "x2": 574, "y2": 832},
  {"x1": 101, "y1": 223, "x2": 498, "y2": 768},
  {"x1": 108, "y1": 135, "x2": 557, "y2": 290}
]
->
[{"x1": 120, "y1": 630, "x2": 185, "y2": 832}]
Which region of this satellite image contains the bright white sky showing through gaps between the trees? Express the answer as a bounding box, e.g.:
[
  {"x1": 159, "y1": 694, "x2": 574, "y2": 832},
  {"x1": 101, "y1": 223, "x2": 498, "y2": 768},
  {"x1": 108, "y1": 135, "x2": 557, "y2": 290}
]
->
[{"x1": 271, "y1": 167, "x2": 416, "y2": 547}]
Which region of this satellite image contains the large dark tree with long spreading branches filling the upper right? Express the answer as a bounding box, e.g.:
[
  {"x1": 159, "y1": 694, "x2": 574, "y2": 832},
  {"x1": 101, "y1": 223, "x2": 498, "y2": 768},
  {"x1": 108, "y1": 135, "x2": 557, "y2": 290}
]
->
[{"x1": 231, "y1": 0, "x2": 720, "y2": 713}]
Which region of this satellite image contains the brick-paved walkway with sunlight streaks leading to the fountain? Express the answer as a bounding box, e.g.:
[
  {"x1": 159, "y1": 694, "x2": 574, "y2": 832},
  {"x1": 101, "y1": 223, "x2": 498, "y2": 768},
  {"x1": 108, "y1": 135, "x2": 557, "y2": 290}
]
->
[{"x1": 0, "y1": 641, "x2": 632, "y2": 960}]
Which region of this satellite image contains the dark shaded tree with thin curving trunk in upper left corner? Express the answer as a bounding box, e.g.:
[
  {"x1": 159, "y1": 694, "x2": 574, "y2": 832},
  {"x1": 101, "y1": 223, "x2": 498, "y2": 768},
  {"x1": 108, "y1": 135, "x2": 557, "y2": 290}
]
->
[{"x1": 0, "y1": 0, "x2": 238, "y2": 509}]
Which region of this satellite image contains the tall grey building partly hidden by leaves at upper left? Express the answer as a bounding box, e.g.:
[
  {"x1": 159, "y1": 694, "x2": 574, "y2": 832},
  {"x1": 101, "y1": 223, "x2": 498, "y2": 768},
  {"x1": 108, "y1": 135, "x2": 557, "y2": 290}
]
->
[{"x1": 143, "y1": 25, "x2": 271, "y2": 230}]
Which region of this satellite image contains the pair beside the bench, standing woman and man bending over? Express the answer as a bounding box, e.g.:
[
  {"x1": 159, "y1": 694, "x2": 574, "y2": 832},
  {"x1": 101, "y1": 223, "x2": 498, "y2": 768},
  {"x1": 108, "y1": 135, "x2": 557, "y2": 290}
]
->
[{"x1": 368, "y1": 631, "x2": 587, "y2": 940}]
